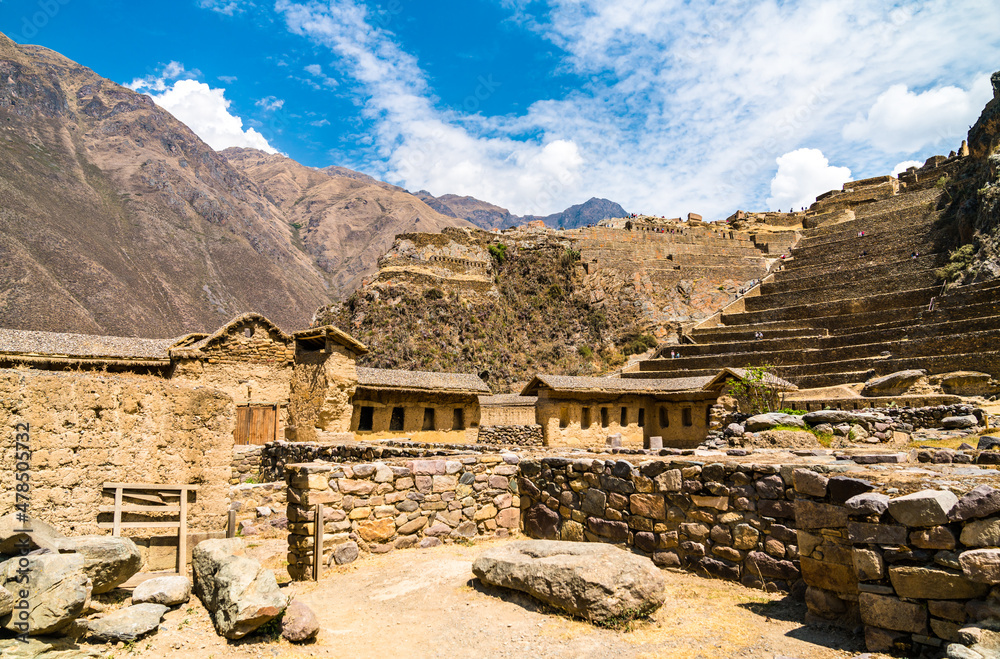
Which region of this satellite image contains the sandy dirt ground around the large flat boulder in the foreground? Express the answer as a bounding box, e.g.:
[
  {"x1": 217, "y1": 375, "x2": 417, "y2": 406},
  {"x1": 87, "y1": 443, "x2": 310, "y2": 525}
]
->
[{"x1": 60, "y1": 540, "x2": 892, "y2": 659}]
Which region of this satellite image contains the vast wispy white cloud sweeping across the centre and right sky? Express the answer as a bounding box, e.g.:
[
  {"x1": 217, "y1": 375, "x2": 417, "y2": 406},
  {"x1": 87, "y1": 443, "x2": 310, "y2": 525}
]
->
[{"x1": 275, "y1": 0, "x2": 1000, "y2": 219}]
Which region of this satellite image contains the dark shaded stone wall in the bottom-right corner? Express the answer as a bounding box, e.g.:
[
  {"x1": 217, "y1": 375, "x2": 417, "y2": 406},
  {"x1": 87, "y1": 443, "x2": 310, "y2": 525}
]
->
[{"x1": 793, "y1": 470, "x2": 1000, "y2": 657}]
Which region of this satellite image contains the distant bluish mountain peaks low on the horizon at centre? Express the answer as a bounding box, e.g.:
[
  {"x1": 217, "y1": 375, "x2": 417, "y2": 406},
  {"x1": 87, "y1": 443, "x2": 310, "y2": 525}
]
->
[{"x1": 414, "y1": 190, "x2": 626, "y2": 229}]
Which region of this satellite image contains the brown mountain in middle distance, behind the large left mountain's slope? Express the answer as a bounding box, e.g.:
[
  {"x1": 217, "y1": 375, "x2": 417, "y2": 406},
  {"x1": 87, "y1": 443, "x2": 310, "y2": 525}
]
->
[{"x1": 222, "y1": 147, "x2": 473, "y2": 298}]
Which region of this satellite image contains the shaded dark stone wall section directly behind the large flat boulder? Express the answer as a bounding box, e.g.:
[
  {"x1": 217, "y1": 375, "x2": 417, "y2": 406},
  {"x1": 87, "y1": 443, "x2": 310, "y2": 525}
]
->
[{"x1": 518, "y1": 458, "x2": 800, "y2": 591}]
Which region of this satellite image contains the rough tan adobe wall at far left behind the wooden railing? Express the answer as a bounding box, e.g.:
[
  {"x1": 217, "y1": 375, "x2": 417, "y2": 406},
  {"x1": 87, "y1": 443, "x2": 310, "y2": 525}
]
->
[{"x1": 0, "y1": 369, "x2": 235, "y2": 567}]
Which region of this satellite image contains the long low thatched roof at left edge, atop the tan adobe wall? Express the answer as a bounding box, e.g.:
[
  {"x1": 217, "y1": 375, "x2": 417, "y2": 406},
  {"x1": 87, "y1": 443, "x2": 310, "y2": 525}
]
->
[{"x1": 0, "y1": 329, "x2": 178, "y2": 362}]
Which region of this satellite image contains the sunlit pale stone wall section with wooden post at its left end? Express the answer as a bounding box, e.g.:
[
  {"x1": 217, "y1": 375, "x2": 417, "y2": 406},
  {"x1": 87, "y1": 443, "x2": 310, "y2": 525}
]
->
[{"x1": 285, "y1": 454, "x2": 520, "y2": 579}]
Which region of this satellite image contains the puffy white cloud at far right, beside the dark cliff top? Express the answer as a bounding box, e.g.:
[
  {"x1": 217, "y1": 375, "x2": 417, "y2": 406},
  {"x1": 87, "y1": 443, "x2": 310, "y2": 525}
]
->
[{"x1": 844, "y1": 75, "x2": 993, "y2": 153}]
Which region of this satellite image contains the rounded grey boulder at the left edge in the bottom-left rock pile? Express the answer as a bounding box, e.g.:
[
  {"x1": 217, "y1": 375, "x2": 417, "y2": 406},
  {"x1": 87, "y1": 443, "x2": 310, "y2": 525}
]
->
[{"x1": 0, "y1": 554, "x2": 91, "y2": 636}]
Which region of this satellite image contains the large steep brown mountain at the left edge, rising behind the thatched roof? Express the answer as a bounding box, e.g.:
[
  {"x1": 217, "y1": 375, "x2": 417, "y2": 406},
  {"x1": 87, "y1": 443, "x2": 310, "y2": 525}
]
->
[{"x1": 0, "y1": 34, "x2": 332, "y2": 337}]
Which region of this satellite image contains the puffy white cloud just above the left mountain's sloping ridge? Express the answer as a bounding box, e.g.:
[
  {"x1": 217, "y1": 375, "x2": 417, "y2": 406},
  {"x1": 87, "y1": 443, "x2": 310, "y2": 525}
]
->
[{"x1": 126, "y1": 62, "x2": 280, "y2": 153}]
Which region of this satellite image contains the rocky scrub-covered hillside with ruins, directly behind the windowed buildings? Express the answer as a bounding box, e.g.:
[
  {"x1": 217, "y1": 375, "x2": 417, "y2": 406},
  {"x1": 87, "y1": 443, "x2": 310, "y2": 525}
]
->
[{"x1": 316, "y1": 227, "x2": 767, "y2": 392}]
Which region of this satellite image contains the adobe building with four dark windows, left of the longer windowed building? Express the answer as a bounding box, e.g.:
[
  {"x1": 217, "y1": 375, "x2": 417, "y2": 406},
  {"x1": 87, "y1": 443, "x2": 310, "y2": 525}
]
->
[{"x1": 350, "y1": 368, "x2": 490, "y2": 443}]
